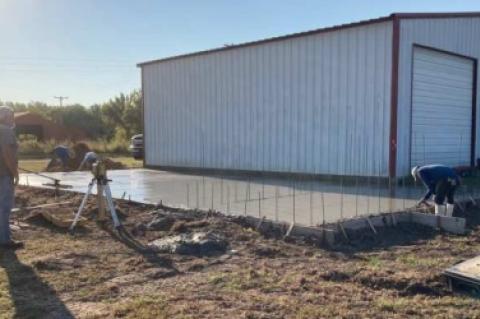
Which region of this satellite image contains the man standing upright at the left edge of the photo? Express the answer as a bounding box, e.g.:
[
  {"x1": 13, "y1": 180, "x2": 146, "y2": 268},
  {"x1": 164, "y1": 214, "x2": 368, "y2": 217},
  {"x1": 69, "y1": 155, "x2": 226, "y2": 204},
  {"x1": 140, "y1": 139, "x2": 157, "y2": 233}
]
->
[{"x1": 0, "y1": 106, "x2": 23, "y2": 249}]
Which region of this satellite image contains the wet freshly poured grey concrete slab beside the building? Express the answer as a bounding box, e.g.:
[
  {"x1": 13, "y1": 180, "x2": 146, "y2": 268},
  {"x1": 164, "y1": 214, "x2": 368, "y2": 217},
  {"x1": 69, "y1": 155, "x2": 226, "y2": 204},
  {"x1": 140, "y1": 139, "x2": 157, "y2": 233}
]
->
[{"x1": 20, "y1": 169, "x2": 432, "y2": 226}]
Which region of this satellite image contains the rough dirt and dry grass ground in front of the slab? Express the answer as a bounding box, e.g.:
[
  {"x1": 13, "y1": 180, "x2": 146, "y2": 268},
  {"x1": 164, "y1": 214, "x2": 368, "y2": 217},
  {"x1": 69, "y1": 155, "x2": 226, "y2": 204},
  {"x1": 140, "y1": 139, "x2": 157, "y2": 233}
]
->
[{"x1": 0, "y1": 187, "x2": 480, "y2": 318}]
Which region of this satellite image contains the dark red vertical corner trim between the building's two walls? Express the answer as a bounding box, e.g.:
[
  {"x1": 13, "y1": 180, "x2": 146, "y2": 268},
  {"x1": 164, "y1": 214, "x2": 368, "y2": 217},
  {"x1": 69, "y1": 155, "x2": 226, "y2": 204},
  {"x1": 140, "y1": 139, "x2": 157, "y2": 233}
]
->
[{"x1": 388, "y1": 15, "x2": 400, "y2": 178}]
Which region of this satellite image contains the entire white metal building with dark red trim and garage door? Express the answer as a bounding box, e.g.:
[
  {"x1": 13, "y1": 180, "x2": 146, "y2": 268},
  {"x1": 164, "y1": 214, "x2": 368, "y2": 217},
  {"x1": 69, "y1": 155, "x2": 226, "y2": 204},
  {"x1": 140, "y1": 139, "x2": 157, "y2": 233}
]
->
[{"x1": 139, "y1": 12, "x2": 480, "y2": 177}]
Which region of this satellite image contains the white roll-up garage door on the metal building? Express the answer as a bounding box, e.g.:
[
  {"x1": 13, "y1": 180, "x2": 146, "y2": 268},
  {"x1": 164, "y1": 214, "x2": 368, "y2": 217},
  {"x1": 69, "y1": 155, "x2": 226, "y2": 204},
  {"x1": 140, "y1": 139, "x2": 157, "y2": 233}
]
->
[{"x1": 411, "y1": 47, "x2": 474, "y2": 166}]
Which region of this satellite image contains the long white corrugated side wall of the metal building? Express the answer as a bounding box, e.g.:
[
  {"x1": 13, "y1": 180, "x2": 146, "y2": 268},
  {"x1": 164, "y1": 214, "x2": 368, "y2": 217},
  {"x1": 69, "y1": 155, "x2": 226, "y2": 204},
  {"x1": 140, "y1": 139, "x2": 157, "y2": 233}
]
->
[{"x1": 142, "y1": 22, "x2": 392, "y2": 176}]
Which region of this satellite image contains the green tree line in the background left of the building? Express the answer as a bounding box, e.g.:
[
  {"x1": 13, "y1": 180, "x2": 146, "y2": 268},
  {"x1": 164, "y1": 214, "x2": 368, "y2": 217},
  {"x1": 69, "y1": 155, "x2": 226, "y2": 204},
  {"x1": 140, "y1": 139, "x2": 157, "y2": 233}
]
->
[{"x1": 0, "y1": 90, "x2": 142, "y2": 140}]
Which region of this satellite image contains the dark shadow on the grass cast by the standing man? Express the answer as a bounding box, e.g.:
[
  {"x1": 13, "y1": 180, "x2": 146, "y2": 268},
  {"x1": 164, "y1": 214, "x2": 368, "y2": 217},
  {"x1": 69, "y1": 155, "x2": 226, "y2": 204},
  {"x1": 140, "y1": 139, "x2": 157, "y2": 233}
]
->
[{"x1": 0, "y1": 250, "x2": 74, "y2": 319}]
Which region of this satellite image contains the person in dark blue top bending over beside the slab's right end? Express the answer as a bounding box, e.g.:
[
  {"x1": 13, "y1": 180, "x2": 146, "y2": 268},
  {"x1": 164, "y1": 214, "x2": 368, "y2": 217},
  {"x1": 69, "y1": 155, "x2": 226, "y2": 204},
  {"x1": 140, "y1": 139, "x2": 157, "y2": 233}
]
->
[{"x1": 412, "y1": 164, "x2": 460, "y2": 217}]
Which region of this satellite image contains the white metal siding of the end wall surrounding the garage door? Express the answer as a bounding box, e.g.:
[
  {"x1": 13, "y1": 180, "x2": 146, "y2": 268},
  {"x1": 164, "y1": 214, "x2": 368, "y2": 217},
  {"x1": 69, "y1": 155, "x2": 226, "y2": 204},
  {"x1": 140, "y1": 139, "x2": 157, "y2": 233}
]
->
[{"x1": 397, "y1": 18, "x2": 480, "y2": 175}]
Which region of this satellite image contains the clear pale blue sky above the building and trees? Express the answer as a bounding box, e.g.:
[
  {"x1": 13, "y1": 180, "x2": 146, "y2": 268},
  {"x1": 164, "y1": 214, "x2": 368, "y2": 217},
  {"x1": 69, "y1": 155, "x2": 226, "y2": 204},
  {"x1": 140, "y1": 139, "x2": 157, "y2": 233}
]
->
[{"x1": 0, "y1": 0, "x2": 480, "y2": 106}]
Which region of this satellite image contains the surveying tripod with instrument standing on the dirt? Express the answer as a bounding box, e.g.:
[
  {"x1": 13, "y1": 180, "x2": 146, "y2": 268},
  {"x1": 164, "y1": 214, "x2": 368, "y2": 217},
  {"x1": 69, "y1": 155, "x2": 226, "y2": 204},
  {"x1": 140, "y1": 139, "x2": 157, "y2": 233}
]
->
[{"x1": 70, "y1": 160, "x2": 122, "y2": 231}]
